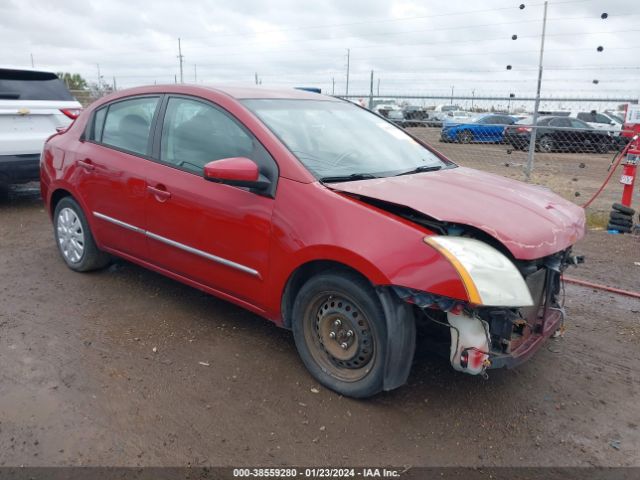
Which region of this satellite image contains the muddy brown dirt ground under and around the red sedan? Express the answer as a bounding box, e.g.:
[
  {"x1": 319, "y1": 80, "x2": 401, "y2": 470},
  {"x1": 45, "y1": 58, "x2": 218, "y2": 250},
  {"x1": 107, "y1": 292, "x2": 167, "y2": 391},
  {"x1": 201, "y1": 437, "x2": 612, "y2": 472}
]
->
[{"x1": 0, "y1": 185, "x2": 640, "y2": 466}]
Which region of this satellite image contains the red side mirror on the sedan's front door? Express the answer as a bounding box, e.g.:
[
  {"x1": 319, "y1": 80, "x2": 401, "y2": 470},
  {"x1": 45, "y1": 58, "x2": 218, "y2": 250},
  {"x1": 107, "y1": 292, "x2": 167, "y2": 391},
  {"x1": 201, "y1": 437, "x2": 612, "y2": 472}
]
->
[{"x1": 204, "y1": 157, "x2": 271, "y2": 191}]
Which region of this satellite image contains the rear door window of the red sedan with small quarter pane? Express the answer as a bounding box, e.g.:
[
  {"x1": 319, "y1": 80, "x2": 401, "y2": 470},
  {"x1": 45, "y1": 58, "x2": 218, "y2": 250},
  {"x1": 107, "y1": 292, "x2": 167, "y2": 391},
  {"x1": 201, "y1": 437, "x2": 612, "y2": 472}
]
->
[{"x1": 101, "y1": 97, "x2": 158, "y2": 155}]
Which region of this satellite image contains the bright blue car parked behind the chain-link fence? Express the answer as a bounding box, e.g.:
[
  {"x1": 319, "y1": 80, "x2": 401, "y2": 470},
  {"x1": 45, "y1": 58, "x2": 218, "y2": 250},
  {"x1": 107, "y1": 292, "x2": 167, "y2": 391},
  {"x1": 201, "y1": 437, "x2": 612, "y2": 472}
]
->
[{"x1": 440, "y1": 113, "x2": 518, "y2": 143}]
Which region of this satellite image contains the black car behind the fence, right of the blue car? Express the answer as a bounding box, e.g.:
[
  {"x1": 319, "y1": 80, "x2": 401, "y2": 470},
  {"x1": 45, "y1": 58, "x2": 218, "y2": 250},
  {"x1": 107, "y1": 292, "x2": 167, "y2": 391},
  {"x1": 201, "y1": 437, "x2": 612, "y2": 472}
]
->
[{"x1": 504, "y1": 116, "x2": 615, "y2": 153}]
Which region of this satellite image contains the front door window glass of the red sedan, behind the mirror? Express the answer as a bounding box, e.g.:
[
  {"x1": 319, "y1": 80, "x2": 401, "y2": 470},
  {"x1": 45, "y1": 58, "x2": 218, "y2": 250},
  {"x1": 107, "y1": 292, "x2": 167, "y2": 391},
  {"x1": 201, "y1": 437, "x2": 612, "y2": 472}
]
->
[{"x1": 160, "y1": 97, "x2": 257, "y2": 174}]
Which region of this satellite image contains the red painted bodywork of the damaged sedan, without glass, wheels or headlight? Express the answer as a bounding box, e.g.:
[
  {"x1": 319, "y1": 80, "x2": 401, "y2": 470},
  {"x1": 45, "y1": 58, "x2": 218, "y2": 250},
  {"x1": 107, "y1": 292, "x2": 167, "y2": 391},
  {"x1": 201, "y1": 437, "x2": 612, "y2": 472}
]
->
[{"x1": 41, "y1": 85, "x2": 584, "y2": 323}]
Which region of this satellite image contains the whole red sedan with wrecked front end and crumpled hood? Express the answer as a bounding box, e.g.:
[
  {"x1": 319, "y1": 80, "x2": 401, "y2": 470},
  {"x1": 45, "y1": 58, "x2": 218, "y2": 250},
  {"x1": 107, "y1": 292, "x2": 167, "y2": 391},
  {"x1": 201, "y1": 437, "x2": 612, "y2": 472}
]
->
[{"x1": 41, "y1": 85, "x2": 584, "y2": 397}]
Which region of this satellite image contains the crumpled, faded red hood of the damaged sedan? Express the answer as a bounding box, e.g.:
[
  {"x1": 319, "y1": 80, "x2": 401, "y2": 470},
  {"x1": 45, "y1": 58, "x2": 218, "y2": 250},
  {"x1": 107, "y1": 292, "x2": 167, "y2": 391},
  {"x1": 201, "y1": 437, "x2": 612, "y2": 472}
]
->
[{"x1": 330, "y1": 167, "x2": 585, "y2": 260}]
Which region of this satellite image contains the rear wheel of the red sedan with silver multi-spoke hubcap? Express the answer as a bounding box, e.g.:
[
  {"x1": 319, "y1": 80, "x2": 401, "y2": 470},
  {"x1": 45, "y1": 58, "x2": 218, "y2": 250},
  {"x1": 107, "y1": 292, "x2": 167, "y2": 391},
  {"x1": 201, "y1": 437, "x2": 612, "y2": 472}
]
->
[{"x1": 53, "y1": 197, "x2": 110, "y2": 272}]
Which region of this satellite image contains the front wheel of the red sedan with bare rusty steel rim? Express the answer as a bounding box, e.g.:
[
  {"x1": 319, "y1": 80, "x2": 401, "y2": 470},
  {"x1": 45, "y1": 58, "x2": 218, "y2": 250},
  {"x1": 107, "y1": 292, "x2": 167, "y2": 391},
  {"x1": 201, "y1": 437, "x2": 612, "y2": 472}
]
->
[{"x1": 292, "y1": 270, "x2": 387, "y2": 398}]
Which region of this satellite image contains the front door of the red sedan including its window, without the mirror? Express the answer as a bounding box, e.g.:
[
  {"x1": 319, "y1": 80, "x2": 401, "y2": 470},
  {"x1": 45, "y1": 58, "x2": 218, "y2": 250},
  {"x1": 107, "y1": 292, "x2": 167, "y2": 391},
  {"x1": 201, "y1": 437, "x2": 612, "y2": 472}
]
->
[{"x1": 146, "y1": 96, "x2": 278, "y2": 305}]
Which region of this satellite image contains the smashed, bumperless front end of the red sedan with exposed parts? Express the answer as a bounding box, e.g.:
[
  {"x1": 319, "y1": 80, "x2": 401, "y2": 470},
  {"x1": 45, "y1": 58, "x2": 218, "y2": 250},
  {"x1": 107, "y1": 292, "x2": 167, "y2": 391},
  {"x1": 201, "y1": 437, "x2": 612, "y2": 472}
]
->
[{"x1": 393, "y1": 248, "x2": 583, "y2": 375}]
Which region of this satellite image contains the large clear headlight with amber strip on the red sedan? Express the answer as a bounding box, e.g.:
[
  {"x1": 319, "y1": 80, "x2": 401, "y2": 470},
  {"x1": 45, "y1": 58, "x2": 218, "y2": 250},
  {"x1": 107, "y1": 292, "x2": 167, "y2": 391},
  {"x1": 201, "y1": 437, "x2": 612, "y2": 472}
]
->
[{"x1": 424, "y1": 235, "x2": 533, "y2": 307}]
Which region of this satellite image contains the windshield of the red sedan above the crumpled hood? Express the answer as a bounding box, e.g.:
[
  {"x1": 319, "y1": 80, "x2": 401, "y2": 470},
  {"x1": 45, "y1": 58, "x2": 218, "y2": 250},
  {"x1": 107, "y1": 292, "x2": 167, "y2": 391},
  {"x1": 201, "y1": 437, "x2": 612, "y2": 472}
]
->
[{"x1": 243, "y1": 99, "x2": 453, "y2": 179}]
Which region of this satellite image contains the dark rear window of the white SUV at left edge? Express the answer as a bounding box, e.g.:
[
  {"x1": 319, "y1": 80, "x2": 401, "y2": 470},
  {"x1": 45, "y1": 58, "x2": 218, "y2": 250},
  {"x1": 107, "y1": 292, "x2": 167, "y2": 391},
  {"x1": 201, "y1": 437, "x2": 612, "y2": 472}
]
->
[{"x1": 0, "y1": 69, "x2": 74, "y2": 101}]
